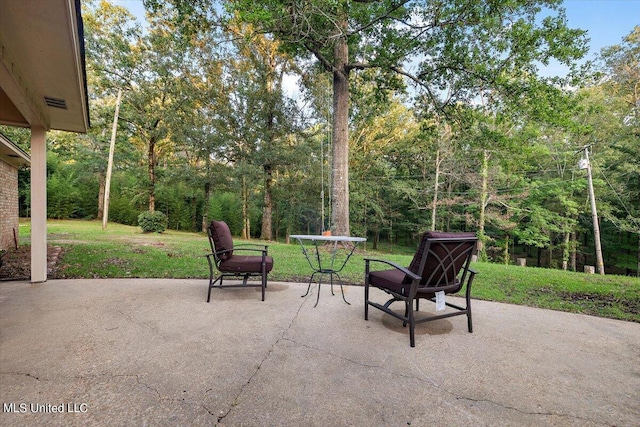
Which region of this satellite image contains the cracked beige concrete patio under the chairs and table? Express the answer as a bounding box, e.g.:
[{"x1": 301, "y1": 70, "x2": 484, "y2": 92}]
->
[{"x1": 0, "y1": 279, "x2": 640, "y2": 426}]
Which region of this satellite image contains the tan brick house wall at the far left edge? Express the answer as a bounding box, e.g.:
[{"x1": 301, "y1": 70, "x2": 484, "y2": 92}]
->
[{"x1": 0, "y1": 160, "x2": 20, "y2": 254}]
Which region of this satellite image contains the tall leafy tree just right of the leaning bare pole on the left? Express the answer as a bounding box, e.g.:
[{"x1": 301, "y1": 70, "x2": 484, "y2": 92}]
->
[{"x1": 87, "y1": 0, "x2": 201, "y2": 212}]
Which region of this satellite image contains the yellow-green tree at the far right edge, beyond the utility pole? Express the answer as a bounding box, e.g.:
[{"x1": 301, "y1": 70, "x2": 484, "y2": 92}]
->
[{"x1": 582, "y1": 26, "x2": 640, "y2": 274}]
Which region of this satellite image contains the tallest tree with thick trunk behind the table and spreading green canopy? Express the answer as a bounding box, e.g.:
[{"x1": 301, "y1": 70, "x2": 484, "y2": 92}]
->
[{"x1": 229, "y1": 0, "x2": 586, "y2": 234}]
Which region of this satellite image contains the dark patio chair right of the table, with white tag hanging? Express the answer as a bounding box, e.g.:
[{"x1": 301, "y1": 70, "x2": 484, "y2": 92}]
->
[{"x1": 364, "y1": 232, "x2": 478, "y2": 347}]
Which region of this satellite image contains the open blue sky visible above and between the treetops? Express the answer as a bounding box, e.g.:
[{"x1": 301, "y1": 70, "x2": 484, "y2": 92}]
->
[{"x1": 111, "y1": 0, "x2": 640, "y2": 74}]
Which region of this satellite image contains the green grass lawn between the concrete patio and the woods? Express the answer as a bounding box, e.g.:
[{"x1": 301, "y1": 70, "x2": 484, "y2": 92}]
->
[{"x1": 15, "y1": 221, "x2": 640, "y2": 322}]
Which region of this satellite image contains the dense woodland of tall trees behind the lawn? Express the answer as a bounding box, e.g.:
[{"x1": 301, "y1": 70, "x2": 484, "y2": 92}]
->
[{"x1": 3, "y1": 0, "x2": 640, "y2": 274}]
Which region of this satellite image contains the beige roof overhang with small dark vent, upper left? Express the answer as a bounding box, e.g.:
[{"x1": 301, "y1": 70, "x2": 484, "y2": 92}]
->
[{"x1": 0, "y1": 0, "x2": 89, "y2": 133}]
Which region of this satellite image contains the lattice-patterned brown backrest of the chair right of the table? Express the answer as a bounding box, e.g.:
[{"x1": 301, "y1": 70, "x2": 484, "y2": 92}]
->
[{"x1": 405, "y1": 231, "x2": 478, "y2": 286}]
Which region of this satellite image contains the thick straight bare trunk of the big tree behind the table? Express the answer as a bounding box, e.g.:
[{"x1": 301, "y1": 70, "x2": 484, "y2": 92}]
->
[{"x1": 331, "y1": 18, "x2": 350, "y2": 236}]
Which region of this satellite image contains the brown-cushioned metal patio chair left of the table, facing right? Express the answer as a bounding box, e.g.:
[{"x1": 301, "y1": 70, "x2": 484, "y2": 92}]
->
[{"x1": 206, "y1": 221, "x2": 273, "y2": 302}]
